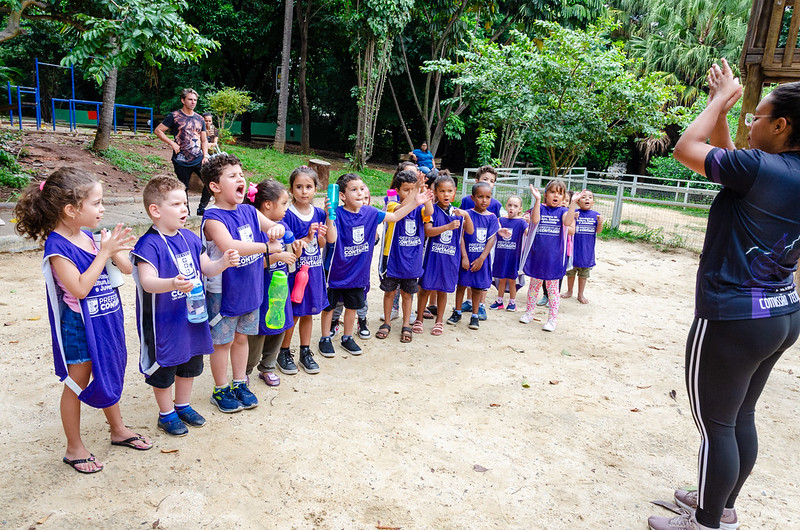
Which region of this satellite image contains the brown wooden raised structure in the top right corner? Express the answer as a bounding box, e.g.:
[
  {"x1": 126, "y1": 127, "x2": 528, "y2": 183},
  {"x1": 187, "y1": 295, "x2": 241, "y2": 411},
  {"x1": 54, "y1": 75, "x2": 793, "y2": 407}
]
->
[{"x1": 736, "y1": 0, "x2": 800, "y2": 148}]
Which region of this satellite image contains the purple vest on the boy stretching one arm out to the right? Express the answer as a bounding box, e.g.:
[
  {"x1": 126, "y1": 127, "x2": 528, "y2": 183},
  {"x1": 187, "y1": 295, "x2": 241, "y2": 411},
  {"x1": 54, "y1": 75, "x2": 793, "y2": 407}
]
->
[{"x1": 328, "y1": 206, "x2": 386, "y2": 289}]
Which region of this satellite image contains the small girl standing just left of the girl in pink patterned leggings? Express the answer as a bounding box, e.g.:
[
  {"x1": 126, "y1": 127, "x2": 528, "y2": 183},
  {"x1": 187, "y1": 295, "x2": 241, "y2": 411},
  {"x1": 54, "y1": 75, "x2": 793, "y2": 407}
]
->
[{"x1": 489, "y1": 195, "x2": 528, "y2": 311}]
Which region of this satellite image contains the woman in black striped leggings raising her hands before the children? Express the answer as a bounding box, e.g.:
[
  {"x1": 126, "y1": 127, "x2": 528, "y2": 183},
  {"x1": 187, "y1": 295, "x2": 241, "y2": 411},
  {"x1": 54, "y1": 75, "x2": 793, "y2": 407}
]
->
[{"x1": 648, "y1": 59, "x2": 800, "y2": 530}]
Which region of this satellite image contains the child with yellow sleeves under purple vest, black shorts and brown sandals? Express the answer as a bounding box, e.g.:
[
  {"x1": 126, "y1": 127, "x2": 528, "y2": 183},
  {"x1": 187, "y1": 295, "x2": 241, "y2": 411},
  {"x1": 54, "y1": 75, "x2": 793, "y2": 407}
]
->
[{"x1": 375, "y1": 170, "x2": 433, "y2": 343}]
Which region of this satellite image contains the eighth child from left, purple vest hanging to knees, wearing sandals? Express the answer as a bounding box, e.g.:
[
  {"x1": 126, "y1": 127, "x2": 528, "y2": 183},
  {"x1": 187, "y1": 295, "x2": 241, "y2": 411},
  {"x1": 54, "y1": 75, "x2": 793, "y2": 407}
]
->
[{"x1": 412, "y1": 174, "x2": 474, "y2": 336}]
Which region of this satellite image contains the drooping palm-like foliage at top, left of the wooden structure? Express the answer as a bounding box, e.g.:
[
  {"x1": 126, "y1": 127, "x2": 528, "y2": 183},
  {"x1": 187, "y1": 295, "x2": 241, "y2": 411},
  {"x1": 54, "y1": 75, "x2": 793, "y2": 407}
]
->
[{"x1": 610, "y1": 0, "x2": 752, "y2": 103}]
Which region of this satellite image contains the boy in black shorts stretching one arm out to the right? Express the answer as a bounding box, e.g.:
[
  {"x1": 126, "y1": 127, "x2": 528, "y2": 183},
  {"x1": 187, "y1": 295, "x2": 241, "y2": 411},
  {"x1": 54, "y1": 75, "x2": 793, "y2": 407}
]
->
[{"x1": 319, "y1": 173, "x2": 430, "y2": 357}]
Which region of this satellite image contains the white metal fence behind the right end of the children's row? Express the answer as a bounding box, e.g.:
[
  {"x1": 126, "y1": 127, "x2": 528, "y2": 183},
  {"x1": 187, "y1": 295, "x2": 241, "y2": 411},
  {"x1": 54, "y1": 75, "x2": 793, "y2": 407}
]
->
[{"x1": 461, "y1": 168, "x2": 720, "y2": 252}]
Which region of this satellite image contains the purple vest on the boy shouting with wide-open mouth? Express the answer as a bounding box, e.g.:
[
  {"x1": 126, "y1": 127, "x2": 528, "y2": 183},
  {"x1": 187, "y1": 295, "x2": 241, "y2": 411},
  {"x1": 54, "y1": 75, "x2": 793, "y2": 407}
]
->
[{"x1": 200, "y1": 204, "x2": 264, "y2": 317}]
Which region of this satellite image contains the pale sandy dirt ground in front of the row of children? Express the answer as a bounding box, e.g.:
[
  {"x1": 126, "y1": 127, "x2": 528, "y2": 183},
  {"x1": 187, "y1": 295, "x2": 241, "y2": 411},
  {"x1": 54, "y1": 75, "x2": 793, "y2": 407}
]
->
[{"x1": 0, "y1": 236, "x2": 800, "y2": 529}]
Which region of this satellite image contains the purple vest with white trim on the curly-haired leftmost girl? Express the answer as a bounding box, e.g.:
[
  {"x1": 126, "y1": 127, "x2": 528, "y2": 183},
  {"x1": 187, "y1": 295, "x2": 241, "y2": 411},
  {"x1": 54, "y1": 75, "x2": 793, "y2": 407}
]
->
[{"x1": 42, "y1": 231, "x2": 128, "y2": 408}]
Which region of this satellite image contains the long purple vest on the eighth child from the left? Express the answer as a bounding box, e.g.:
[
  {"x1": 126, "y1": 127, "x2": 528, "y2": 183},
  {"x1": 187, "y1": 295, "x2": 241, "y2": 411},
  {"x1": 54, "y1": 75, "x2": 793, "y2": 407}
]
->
[{"x1": 419, "y1": 204, "x2": 463, "y2": 293}]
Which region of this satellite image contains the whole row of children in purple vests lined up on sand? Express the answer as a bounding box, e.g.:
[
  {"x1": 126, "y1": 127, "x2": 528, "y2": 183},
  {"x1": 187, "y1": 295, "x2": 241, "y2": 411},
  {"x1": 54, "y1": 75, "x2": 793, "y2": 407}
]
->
[{"x1": 10, "y1": 154, "x2": 602, "y2": 473}]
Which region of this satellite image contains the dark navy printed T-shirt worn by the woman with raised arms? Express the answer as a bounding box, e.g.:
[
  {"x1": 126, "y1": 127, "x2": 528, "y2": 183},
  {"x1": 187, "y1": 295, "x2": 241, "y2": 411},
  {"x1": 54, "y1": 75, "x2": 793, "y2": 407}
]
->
[{"x1": 695, "y1": 148, "x2": 800, "y2": 320}]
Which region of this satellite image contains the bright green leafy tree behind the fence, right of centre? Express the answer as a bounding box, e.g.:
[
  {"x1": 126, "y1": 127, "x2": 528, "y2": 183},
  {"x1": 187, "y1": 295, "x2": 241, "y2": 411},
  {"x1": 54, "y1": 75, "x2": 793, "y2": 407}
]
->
[{"x1": 426, "y1": 20, "x2": 672, "y2": 175}]
